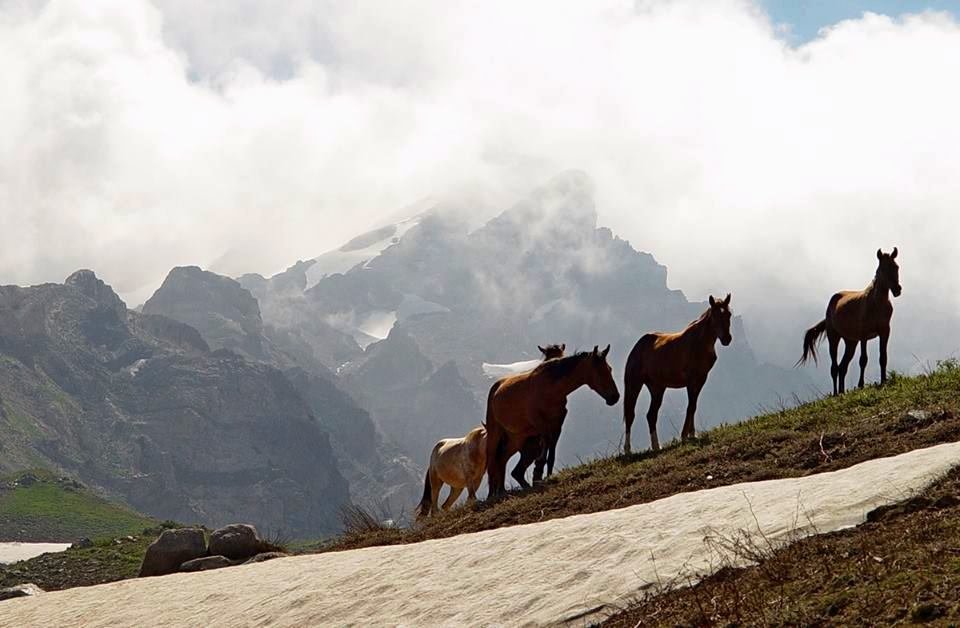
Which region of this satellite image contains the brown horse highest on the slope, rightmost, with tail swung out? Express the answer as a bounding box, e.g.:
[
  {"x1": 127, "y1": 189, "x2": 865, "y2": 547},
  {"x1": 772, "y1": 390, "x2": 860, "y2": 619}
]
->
[{"x1": 797, "y1": 247, "x2": 902, "y2": 395}]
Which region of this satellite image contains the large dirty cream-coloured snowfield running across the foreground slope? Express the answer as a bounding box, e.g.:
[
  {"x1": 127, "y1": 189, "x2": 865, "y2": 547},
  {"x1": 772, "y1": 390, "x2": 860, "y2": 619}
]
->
[{"x1": 0, "y1": 443, "x2": 960, "y2": 626}]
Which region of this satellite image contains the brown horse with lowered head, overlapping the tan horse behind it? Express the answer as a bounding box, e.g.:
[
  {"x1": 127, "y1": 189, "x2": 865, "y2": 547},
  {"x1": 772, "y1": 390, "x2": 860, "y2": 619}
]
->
[{"x1": 486, "y1": 345, "x2": 620, "y2": 498}]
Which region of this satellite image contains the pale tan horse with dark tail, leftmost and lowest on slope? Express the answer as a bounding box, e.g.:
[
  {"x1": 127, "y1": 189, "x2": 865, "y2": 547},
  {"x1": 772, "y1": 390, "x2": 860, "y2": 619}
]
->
[{"x1": 417, "y1": 427, "x2": 487, "y2": 519}]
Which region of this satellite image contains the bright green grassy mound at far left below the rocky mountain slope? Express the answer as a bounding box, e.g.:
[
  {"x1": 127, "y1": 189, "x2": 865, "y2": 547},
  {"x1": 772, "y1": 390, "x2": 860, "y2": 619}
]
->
[{"x1": 0, "y1": 470, "x2": 156, "y2": 542}]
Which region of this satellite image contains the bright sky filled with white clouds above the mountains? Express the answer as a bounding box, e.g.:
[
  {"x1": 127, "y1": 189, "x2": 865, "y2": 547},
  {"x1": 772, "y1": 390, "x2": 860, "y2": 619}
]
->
[{"x1": 0, "y1": 0, "x2": 960, "y2": 366}]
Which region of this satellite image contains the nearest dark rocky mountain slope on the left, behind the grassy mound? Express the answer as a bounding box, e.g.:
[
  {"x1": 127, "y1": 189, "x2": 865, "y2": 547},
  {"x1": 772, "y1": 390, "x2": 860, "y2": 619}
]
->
[{"x1": 0, "y1": 271, "x2": 349, "y2": 536}]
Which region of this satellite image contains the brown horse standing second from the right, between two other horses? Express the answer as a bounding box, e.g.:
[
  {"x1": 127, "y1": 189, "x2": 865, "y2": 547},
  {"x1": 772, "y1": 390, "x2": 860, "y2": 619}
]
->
[{"x1": 623, "y1": 294, "x2": 733, "y2": 454}]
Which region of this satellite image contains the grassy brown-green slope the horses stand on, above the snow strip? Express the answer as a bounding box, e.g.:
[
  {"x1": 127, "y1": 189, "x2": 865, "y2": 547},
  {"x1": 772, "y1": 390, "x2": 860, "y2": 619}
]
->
[{"x1": 321, "y1": 364, "x2": 960, "y2": 551}]
